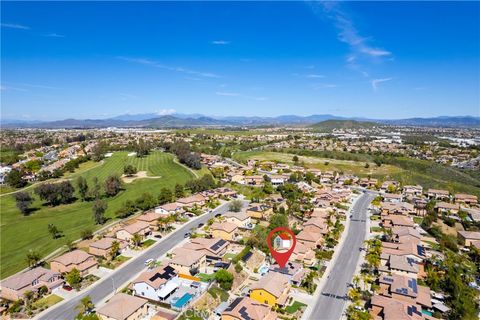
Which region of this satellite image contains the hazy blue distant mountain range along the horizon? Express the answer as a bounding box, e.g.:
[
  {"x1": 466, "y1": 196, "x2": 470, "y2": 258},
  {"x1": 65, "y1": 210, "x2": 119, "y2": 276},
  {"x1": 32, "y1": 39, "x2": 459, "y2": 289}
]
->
[{"x1": 0, "y1": 113, "x2": 480, "y2": 129}]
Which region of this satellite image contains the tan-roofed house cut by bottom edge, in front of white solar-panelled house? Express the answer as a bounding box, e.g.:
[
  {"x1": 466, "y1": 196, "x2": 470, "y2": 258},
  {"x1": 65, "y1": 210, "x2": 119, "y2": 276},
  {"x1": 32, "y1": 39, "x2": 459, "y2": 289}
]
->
[{"x1": 97, "y1": 293, "x2": 148, "y2": 320}]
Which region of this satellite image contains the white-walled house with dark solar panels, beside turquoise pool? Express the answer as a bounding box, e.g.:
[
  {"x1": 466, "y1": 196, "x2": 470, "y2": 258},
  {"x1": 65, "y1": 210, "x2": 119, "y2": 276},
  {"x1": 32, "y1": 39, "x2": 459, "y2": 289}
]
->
[{"x1": 132, "y1": 265, "x2": 178, "y2": 301}]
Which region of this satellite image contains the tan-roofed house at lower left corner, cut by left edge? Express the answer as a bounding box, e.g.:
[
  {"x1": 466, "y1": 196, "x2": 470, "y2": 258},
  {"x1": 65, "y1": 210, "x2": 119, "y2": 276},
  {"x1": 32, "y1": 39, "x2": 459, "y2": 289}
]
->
[{"x1": 0, "y1": 267, "x2": 63, "y2": 301}]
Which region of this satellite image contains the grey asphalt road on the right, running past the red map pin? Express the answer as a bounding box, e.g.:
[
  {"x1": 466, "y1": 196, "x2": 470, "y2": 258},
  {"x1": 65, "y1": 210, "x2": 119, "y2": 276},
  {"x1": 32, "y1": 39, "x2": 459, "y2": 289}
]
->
[{"x1": 309, "y1": 193, "x2": 375, "y2": 320}]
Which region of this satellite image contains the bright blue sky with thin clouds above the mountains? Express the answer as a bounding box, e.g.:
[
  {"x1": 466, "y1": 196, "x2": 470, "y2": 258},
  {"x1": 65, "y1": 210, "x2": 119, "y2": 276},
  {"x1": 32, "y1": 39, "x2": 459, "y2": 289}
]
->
[{"x1": 1, "y1": 2, "x2": 480, "y2": 120}]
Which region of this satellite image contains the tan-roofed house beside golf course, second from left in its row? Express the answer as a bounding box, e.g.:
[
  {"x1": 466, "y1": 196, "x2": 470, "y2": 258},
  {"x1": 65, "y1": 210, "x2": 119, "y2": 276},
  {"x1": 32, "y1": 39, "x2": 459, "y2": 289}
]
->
[{"x1": 50, "y1": 250, "x2": 98, "y2": 276}]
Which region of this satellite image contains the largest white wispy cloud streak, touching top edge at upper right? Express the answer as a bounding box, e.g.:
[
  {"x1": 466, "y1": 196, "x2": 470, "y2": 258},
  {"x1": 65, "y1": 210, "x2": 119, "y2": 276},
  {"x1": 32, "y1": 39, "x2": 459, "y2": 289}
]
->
[{"x1": 310, "y1": 1, "x2": 392, "y2": 63}]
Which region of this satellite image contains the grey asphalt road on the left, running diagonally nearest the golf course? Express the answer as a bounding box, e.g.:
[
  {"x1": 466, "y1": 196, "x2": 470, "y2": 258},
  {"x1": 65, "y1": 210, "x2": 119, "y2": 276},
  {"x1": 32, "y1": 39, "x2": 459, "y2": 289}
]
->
[{"x1": 38, "y1": 203, "x2": 244, "y2": 320}]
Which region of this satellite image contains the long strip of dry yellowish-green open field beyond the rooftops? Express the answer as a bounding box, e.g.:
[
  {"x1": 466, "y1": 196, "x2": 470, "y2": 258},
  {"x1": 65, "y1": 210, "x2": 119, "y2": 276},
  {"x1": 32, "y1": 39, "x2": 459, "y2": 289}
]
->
[{"x1": 233, "y1": 151, "x2": 401, "y2": 175}]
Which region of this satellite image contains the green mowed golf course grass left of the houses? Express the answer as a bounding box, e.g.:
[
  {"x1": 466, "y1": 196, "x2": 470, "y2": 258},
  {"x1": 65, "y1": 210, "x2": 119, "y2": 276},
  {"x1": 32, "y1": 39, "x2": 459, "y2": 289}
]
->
[{"x1": 0, "y1": 152, "x2": 194, "y2": 278}]
